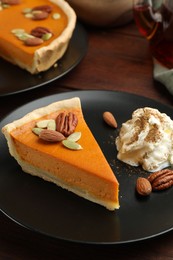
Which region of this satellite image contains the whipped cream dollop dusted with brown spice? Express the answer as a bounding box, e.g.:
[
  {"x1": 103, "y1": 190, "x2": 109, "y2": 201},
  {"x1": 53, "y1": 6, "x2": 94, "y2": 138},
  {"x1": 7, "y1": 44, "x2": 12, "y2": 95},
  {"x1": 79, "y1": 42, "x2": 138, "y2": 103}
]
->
[{"x1": 115, "y1": 107, "x2": 173, "y2": 172}]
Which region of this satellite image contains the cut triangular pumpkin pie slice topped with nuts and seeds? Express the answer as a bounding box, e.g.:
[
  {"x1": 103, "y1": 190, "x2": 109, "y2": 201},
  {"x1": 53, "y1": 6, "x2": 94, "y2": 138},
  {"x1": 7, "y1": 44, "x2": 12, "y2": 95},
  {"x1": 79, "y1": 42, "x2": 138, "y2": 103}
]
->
[{"x1": 2, "y1": 97, "x2": 119, "y2": 210}]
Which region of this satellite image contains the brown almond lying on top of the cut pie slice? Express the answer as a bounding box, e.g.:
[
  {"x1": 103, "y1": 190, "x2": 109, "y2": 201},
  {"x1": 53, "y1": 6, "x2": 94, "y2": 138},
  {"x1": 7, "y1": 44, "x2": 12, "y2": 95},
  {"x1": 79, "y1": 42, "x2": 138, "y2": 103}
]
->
[{"x1": 39, "y1": 129, "x2": 65, "y2": 143}]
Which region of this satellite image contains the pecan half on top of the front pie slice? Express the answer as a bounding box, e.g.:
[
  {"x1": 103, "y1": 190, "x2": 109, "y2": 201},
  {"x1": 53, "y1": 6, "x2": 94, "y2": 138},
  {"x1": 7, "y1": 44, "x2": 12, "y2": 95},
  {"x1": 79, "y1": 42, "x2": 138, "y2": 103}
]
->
[{"x1": 56, "y1": 112, "x2": 78, "y2": 136}]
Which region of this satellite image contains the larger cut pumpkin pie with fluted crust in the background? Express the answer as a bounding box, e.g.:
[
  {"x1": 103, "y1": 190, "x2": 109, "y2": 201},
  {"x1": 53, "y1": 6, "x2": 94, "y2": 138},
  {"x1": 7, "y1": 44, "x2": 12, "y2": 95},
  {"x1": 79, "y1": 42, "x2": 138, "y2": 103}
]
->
[{"x1": 0, "y1": 0, "x2": 76, "y2": 74}]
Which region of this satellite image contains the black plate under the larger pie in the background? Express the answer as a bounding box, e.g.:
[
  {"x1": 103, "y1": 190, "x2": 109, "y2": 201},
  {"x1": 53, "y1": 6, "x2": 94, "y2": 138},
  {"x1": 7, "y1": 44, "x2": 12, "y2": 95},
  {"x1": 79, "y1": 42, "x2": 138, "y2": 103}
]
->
[{"x1": 0, "y1": 23, "x2": 88, "y2": 96}]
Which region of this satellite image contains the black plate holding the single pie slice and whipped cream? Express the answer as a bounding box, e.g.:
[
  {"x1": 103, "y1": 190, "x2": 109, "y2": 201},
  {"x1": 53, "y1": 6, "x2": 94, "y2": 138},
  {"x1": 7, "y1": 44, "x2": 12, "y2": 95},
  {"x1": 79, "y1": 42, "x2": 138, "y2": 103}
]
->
[{"x1": 0, "y1": 91, "x2": 173, "y2": 244}]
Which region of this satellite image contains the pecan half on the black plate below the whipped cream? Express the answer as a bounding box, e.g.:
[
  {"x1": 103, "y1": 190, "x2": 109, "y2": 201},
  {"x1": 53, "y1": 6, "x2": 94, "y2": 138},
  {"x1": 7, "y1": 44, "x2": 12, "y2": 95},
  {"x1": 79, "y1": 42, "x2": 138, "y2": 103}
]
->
[{"x1": 148, "y1": 169, "x2": 173, "y2": 190}]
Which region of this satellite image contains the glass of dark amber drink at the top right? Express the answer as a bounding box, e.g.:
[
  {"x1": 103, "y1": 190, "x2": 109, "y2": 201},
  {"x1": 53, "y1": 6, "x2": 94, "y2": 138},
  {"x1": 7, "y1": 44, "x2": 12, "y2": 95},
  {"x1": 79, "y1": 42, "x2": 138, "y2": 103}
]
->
[{"x1": 133, "y1": 0, "x2": 173, "y2": 68}]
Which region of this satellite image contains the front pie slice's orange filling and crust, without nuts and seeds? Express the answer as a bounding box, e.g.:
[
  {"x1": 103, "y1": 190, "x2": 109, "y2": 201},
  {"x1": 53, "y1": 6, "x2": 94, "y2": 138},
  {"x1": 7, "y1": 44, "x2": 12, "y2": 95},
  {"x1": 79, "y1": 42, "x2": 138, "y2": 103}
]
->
[{"x1": 2, "y1": 98, "x2": 119, "y2": 210}]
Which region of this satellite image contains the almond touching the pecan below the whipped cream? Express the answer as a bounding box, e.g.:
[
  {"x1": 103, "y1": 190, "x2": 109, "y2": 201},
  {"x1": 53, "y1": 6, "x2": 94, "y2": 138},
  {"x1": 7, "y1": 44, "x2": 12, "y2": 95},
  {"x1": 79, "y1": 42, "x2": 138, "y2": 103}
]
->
[{"x1": 136, "y1": 177, "x2": 152, "y2": 196}]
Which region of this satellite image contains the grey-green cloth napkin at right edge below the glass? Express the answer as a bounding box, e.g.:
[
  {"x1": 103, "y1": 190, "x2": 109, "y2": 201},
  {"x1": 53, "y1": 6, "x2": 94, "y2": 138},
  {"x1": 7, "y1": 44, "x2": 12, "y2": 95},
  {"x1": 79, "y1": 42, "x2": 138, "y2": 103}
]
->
[{"x1": 153, "y1": 59, "x2": 173, "y2": 95}]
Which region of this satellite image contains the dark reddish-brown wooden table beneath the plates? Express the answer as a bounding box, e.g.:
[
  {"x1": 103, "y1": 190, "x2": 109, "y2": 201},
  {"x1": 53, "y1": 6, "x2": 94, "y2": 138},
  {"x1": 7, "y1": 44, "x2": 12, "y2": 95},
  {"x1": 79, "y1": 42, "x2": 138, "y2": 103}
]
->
[{"x1": 0, "y1": 22, "x2": 173, "y2": 260}]
